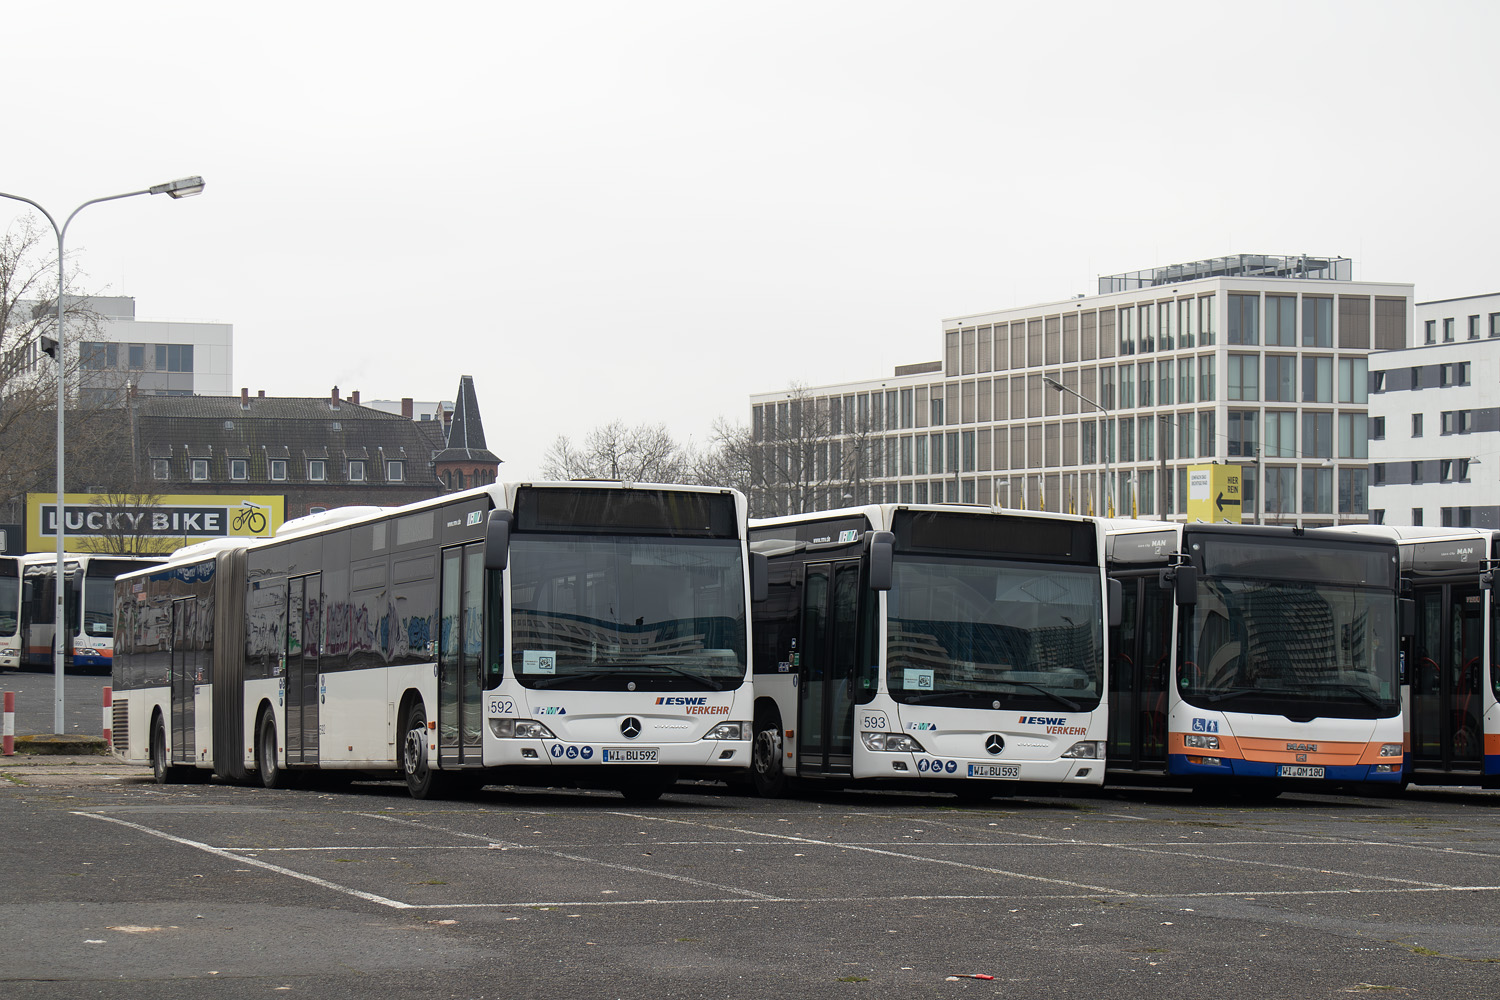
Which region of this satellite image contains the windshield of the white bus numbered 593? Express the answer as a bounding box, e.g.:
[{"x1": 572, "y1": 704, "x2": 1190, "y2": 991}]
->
[{"x1": 887, "y1": 556, "x2": 1104, "y2": 712}]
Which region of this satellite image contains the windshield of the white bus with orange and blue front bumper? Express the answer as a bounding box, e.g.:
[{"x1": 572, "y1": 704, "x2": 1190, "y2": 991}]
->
[{"x1": 1178, "y1": 577, "x2": 1401, "y2": 718}]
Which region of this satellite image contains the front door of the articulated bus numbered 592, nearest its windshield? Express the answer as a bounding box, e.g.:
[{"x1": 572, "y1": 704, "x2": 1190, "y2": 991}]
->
[{"x1": 438, "y1": 544, "x2": 485, "y2": 768}]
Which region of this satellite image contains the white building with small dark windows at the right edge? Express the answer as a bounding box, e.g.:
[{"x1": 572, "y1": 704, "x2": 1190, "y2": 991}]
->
[{"x1": 1370, "y1": 292, "x2": 1500, "y2": 528}]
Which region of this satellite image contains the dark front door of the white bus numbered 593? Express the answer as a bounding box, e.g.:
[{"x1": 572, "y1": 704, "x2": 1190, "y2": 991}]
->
[{"x1": 797, "y1": 561, "x2": 860, "y2": 775}]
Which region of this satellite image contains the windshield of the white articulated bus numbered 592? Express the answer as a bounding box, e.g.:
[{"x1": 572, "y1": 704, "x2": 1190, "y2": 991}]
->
[{"x1": 506, "y1": 534, "x2": 746, "y2": 691}]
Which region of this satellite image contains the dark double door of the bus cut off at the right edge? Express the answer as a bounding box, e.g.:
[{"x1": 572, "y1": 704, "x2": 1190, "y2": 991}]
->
[{"x1": 1407, "y1": 583, "x2": 1484, "y2": 772}]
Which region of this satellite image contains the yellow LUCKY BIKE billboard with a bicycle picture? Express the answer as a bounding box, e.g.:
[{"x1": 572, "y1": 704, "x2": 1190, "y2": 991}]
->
[{"x1": 26, "y1": 493, "x2": 287, "y2": 555}]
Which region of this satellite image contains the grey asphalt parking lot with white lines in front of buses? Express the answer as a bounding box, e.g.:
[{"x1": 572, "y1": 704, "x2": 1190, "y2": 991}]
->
[{"x1": 0, "y1": 759, "x2": 1500, "y2": 1000}]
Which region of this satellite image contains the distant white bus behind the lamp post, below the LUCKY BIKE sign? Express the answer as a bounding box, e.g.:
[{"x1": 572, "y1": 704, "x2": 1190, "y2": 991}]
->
[{"x1": 20, "y1": 552, "x2": 162, "y2": 673}]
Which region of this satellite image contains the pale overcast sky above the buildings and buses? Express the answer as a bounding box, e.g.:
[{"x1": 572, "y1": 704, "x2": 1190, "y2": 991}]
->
[{"x1": 0, "y1": 0, "x2": 1500, "y2": 478}]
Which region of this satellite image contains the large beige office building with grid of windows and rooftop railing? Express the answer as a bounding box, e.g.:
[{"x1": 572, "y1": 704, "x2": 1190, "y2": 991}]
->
[{"x1": 750, "y1": 255, "x2": 1413, "y2": 526}]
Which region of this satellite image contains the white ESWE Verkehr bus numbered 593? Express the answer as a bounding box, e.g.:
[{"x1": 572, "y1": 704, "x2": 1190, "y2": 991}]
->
[{"x1": 750, "y1": 505, "x2": 1107, "y2": 798}]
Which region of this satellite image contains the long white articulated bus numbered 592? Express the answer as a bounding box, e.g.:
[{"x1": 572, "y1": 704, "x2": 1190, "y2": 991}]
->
[{"x1": 113, "y1": 483, "x2": 761, "y2": 801}]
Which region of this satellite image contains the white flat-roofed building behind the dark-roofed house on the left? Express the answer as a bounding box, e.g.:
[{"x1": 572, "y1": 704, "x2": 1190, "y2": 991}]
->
[{"x1": 78, "y1": 295, "x2": 234, "y2": 402}]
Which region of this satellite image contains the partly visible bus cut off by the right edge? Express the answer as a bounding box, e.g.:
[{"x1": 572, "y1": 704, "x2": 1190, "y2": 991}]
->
[{"x1": 1332, "y1": 525, "x2": 1500, "y2": 789}]
